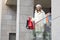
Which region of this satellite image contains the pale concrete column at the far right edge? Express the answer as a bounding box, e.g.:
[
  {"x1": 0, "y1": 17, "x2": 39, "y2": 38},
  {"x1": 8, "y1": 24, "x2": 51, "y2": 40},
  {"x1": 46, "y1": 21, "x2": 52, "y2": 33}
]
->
[{"x1": 51, "y1": 0, "x2": 60, "y2": 40}]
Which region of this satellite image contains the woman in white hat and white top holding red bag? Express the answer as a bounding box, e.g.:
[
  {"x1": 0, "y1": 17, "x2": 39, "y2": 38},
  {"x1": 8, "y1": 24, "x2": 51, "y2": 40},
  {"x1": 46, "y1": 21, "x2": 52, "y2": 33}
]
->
[{"x1": 32, "y1": 4, "x2": 45, "y2": 40}]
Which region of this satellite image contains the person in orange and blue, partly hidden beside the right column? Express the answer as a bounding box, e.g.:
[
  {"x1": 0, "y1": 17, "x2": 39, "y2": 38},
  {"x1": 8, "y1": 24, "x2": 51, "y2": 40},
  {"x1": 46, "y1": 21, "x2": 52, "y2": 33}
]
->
[{"x1": 45, "y1": 12, "x2": 51, "y2": 40}]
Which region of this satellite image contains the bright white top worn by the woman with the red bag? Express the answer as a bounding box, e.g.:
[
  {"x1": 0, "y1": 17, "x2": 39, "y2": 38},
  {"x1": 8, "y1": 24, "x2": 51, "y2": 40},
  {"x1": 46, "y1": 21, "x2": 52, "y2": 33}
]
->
[{"x1": 33, "y1": 10, "x2": 45, "y2": 23}]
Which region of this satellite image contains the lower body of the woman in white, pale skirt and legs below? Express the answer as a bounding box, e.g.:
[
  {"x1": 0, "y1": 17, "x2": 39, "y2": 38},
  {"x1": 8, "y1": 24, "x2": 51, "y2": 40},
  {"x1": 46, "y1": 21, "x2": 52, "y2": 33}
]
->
[{"x1": 35, "y1": 22, "x2": 44, "y2": 39}]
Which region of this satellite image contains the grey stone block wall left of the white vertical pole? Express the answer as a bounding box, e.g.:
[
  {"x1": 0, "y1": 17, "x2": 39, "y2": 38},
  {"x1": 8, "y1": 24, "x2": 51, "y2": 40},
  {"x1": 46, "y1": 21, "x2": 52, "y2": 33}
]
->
[{"x1": 1, "y1": 0, "x2": 16, "y2": 40}]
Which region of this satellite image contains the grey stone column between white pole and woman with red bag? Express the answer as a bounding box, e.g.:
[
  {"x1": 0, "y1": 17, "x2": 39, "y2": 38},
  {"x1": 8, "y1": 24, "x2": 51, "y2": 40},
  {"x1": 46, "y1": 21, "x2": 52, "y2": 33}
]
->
[{"x1": 19, "y1": 0, "x2": 34, "y2": 40}]
